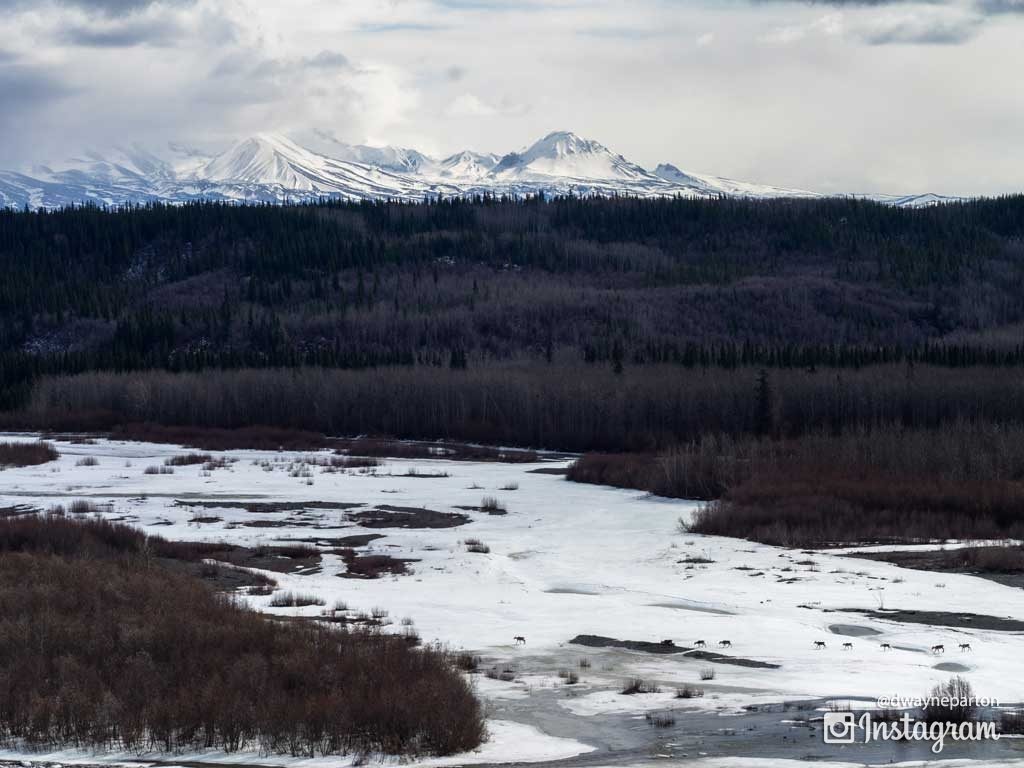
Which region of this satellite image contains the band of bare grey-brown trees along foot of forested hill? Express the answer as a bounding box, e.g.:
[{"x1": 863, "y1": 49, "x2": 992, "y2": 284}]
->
[{"x1": 12, "y1": 364, "x2": 1024, "y2": 452}]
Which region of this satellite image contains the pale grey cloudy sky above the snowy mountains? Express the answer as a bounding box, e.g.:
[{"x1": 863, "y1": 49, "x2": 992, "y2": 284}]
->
[{"x1": 0, "y1": 0, "x2": 1024, "y2": 194}]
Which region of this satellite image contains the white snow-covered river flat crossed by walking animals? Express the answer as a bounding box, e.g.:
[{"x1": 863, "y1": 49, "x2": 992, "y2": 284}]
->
[{"x1": 0, "y1": 435, "x2": 1024, "y2": 768}]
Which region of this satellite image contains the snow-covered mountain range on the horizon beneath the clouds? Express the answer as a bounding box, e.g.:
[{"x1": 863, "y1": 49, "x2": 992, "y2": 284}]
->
[{"x1": 0, "y1": 131, "x2": 957, "y2": 209}]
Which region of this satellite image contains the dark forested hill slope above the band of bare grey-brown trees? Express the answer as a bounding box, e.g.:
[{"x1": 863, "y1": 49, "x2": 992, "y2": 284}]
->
[{"x1": 0, "y1": 197, "x2": 1024, "y2": 403}]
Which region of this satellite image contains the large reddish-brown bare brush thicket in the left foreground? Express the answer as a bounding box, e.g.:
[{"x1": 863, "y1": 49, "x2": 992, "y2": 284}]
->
[{"x1": 0, "y1": 517, "x2": 484, "y2": 757}]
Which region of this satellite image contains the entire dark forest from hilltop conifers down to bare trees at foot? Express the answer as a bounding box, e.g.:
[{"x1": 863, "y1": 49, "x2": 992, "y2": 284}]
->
[{"x1": 0, "y1": 197, "x2": 1024, "y2": 451}]
